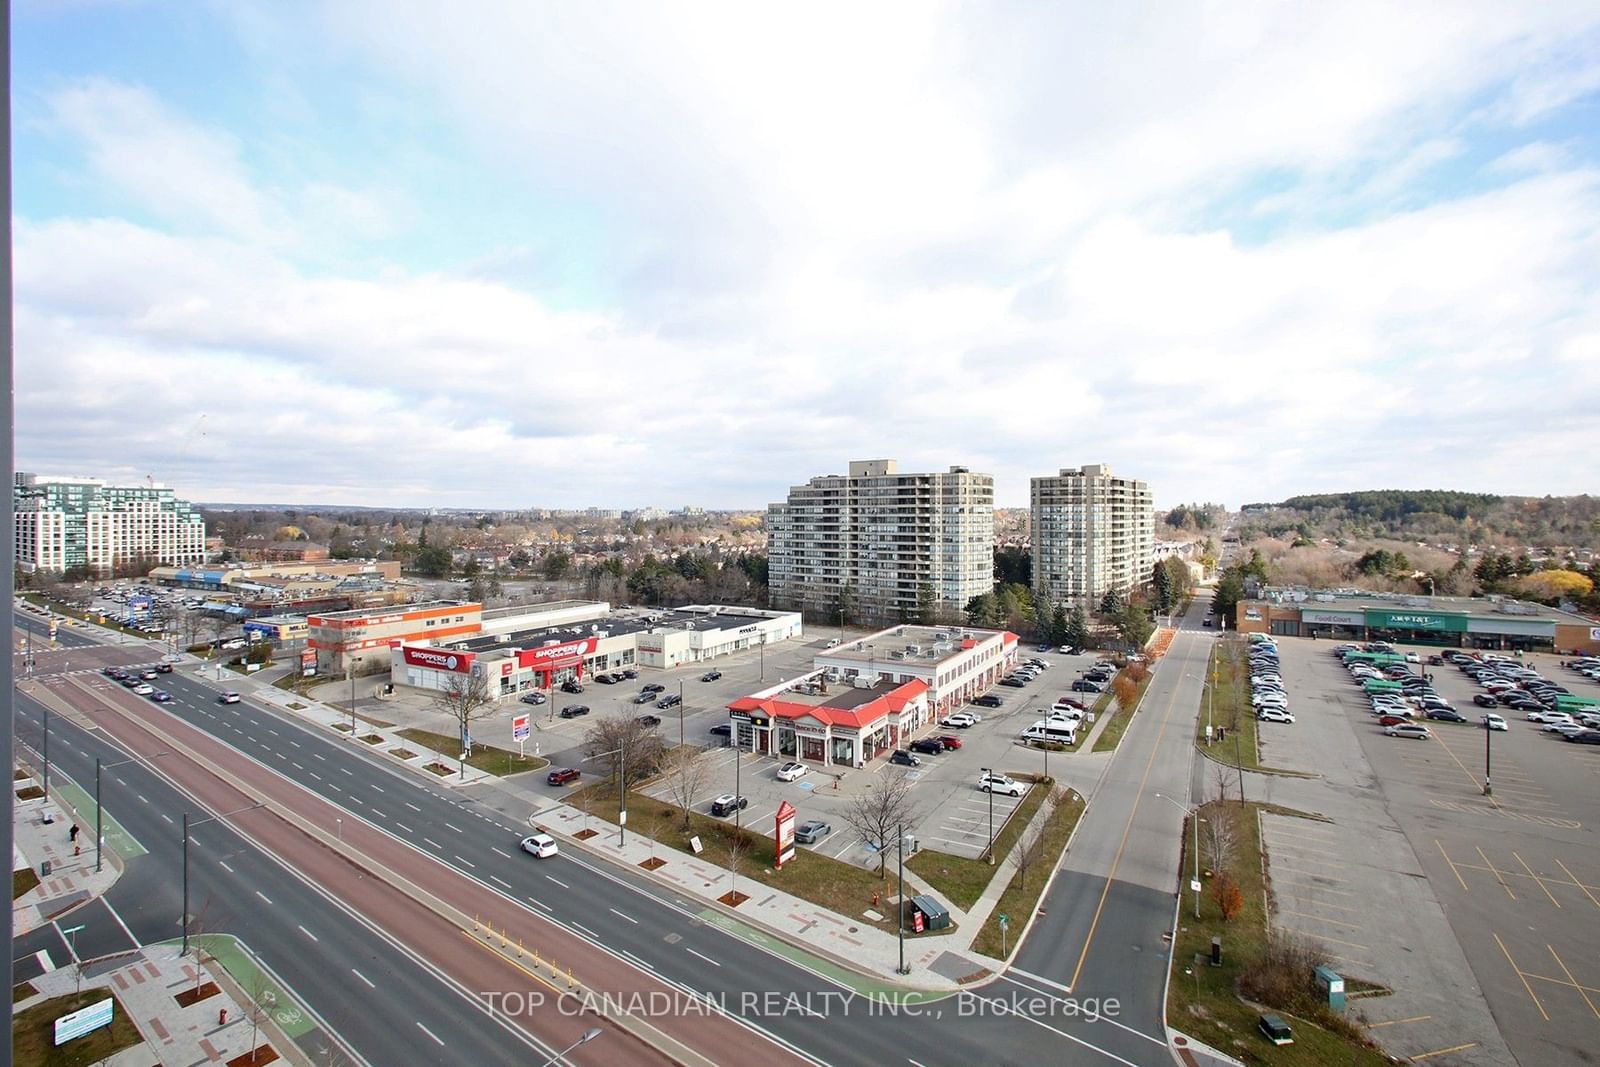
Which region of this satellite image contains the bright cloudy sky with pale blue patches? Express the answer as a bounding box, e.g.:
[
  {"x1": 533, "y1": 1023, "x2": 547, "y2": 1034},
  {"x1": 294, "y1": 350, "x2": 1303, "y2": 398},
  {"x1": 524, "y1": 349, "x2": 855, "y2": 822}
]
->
[{"x1": 13, "y1": 0, "x2": 1600, "y2": 507}]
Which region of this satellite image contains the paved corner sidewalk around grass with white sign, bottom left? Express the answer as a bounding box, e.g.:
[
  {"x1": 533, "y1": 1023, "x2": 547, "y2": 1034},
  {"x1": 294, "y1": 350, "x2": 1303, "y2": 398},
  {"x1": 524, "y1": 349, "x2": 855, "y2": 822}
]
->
[{"x1": 13, "y1": 945, "x2": 297, "y2": 1067}]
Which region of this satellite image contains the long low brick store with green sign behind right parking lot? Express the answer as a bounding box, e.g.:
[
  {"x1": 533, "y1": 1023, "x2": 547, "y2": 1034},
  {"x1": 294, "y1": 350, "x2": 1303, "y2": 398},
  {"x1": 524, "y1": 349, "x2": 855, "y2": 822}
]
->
[{"x1": 1234, "y1": 587, "x2": 1600, "y2": 654}]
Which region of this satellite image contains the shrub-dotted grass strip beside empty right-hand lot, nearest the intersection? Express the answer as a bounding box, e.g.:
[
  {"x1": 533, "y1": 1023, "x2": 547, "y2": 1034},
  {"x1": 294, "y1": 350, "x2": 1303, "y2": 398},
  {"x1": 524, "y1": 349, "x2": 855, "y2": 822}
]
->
[{"x1": 1166, "y1": 800, "x2": 1390, "y2": 1067}]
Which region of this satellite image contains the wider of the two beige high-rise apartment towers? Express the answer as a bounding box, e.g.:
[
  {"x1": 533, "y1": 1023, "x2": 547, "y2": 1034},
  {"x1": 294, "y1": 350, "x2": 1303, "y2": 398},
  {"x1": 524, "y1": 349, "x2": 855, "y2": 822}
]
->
[{"x1": 766, "y1": 459, "x2": 995, "y2": 622}]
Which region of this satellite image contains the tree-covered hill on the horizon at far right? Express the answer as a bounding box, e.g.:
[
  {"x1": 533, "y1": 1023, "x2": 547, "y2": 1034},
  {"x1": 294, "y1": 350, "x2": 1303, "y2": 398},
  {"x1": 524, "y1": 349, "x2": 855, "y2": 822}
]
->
[{"x1": 1240, "y1": 490, "x2": 1600, "y2": 549}]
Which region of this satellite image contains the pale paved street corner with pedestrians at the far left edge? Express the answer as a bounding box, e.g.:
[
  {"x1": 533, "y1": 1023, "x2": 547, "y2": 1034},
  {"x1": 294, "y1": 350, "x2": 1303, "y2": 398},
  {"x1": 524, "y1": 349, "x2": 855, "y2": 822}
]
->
[{"x1": 11, "y1": 767, "x2": 122, "y2": 937}]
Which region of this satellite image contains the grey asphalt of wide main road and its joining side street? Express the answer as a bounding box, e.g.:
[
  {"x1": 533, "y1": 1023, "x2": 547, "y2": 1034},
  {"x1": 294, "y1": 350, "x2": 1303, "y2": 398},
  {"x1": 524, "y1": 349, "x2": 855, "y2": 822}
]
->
[{"x1": 18, "y1": 604, "x2": 1208, "y2": 1065}]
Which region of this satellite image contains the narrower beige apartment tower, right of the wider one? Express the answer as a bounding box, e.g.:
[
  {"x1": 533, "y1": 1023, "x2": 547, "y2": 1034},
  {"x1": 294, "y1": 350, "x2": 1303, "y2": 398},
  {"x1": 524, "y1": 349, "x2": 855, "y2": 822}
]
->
[{"x1": 1032, "y1": 464, "x2": 1155, "y2": 609}]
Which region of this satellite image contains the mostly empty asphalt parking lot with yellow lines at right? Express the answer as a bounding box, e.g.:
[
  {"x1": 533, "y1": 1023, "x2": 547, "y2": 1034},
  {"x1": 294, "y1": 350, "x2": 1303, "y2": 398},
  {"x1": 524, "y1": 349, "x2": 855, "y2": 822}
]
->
[{"x1": 1261, "y1": 638, "x2": 1600, "y2": 1064}]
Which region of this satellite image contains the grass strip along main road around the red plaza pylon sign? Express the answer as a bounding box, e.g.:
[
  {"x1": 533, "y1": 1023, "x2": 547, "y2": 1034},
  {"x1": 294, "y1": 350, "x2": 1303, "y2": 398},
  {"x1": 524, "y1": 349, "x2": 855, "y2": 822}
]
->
[{"x1": 563, "y1": 779, "x2": 908, "y2": 933}]
